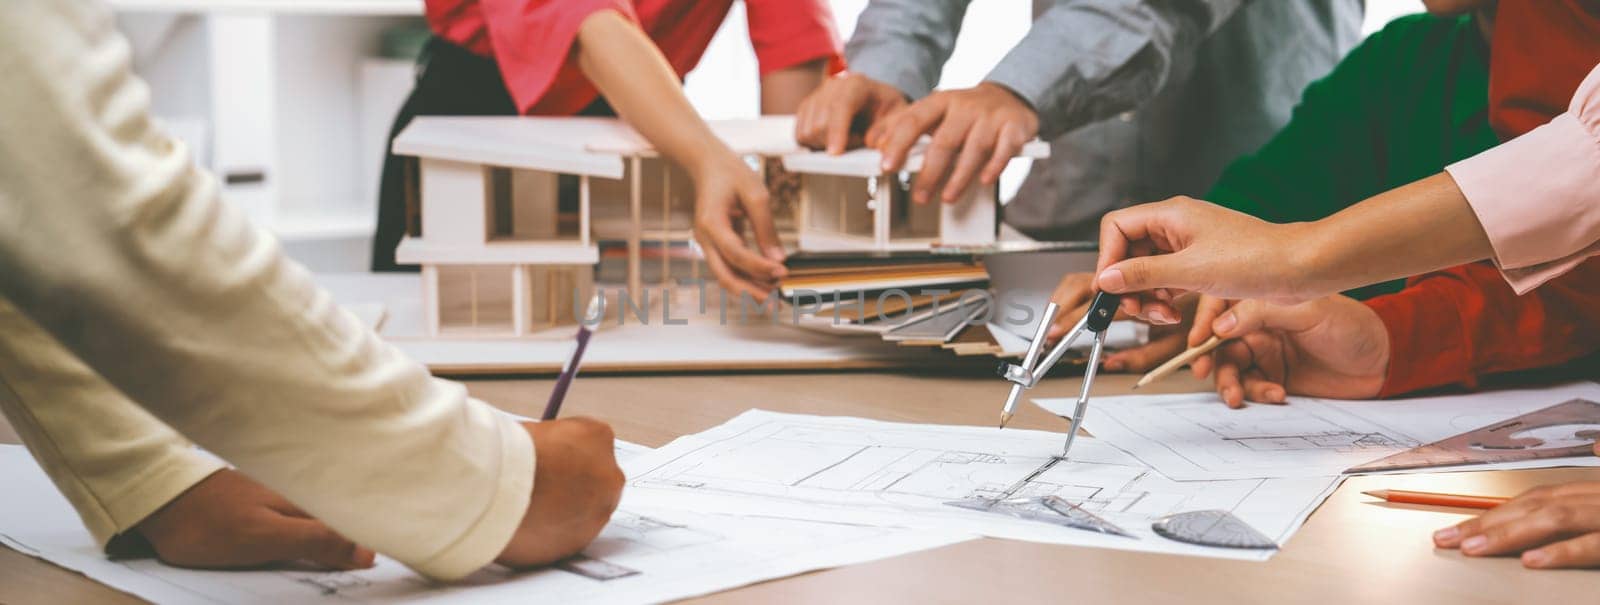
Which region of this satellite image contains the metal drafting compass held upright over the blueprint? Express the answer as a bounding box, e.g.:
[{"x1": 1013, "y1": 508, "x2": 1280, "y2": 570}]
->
[{"x1": 1000, "y1": 291, "x2": 1122, "y2": 458}]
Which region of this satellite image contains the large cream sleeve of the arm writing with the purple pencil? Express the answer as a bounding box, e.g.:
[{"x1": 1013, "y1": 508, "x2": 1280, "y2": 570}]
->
[{"x1": 0, "y1": 0, "x2": 534, "y2": 578}]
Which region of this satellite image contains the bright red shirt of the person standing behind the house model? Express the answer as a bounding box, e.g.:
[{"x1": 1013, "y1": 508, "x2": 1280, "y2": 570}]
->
[{"x1": 427, "y1": 0, "x2": 843, "y2": 115}]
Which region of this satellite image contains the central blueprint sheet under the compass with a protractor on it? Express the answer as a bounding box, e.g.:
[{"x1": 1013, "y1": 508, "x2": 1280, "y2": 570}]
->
[{"x1": 622, "y1": 410, "x2": 1338, "y2": 560}]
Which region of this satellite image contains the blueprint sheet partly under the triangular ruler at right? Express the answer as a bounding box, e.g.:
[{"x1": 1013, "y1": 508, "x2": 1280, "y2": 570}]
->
[{"x1": 1034, "y1": 383, "x2": 1600, "y2": 480}]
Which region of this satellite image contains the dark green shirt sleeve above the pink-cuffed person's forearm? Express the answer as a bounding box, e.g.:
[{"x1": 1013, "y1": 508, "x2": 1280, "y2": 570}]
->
[{"x1": 1206, "y1": 14, "x2": 1499, "y2": 298}]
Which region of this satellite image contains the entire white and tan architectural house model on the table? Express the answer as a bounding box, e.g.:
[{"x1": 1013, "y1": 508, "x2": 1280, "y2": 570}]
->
[{"x1": 394, "y1": 117, "x2": 1048, "y2": 338}]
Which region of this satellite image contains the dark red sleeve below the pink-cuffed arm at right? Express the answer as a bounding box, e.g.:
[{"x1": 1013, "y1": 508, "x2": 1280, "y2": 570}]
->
[{"x1": 1366, "y1": 259, "x2": 1600, "y2": 397}]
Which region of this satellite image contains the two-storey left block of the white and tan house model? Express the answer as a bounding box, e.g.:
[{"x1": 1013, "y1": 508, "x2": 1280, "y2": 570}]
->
[{"x1": 394, "y1": 118, "x2": 624, "y2": 336}]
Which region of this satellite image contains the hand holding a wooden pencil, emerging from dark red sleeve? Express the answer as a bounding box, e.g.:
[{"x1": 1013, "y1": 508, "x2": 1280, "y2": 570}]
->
[{"x1": 1190, "y1": 296, "x2": 1389, "y2": 408}]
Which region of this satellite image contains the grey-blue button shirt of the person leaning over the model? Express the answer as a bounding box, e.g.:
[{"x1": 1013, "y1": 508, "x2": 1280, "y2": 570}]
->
[{"x1": 845, "y1": 0, "x2": 1363, "y2": 240}]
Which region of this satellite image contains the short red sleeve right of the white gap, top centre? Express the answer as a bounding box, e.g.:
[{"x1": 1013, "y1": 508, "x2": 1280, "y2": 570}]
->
[{"x1": 744, "y1": 0, "x2": 845, "y2": 75}]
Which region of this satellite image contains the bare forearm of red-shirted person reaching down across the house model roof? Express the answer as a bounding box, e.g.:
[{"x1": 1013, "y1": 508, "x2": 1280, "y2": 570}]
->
[{"x1": 578, "y1": 11, "x2": 734, "y2": 174}]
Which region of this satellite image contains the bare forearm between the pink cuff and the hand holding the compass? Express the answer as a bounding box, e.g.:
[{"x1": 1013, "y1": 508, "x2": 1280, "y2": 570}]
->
[{"x1": 1296, "y1": 173, "x2": 1493, "y2": 293}]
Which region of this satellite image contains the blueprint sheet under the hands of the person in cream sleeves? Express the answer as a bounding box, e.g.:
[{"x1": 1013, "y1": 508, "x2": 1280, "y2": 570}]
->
[{"x1": 0, "y1": 442, "x2": 968, "y2": 603}]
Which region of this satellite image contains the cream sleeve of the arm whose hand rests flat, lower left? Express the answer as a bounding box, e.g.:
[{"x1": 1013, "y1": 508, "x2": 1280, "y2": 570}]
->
[{"x1": 0, "y1": 298, "x2": 222, "y2": 547}]
